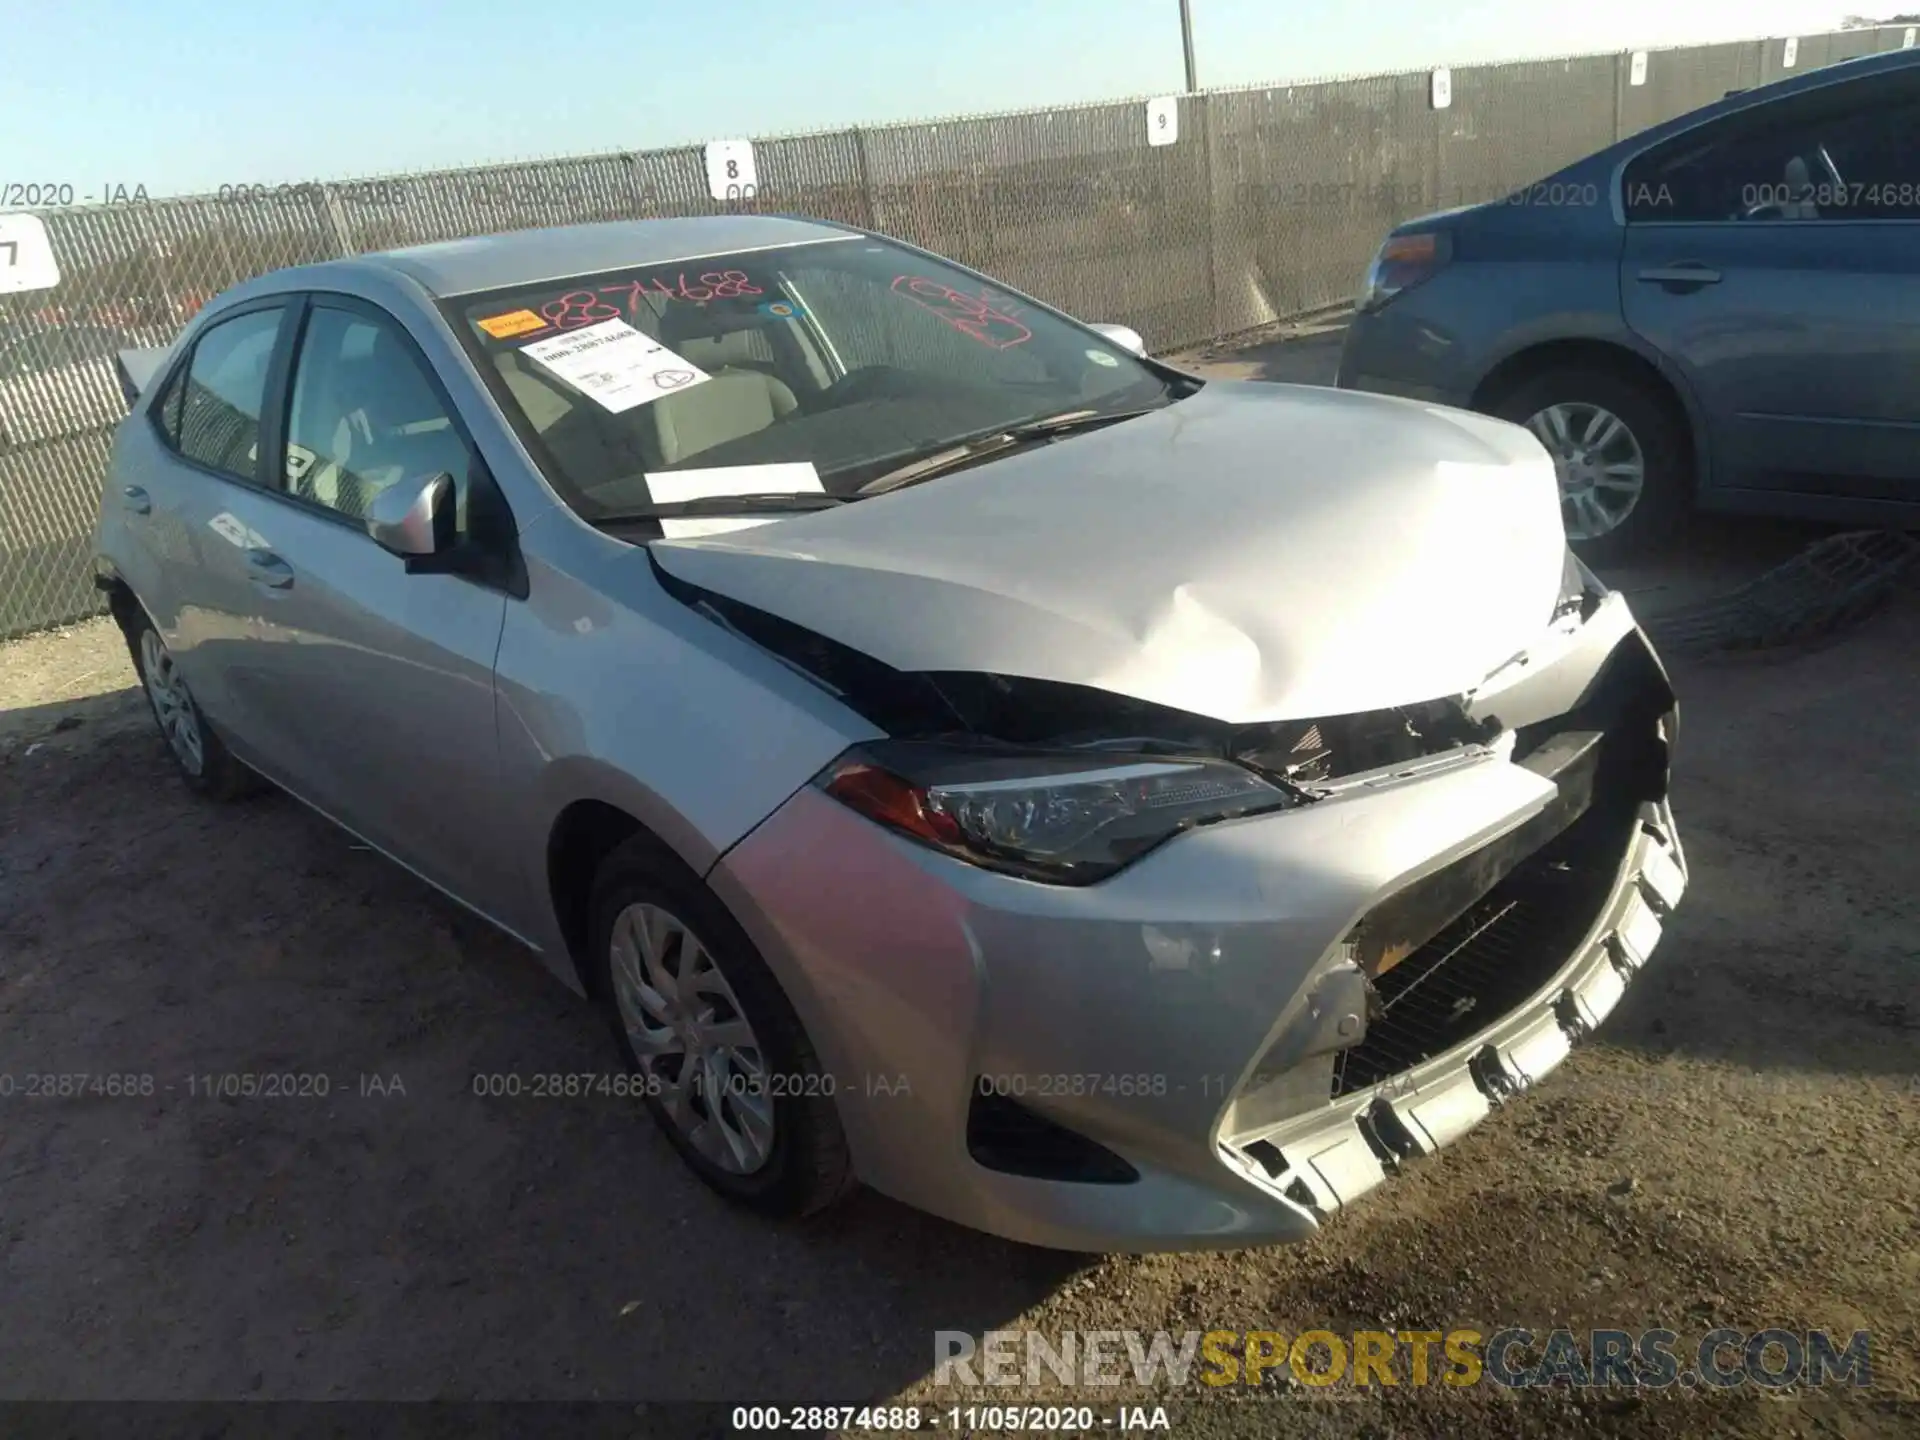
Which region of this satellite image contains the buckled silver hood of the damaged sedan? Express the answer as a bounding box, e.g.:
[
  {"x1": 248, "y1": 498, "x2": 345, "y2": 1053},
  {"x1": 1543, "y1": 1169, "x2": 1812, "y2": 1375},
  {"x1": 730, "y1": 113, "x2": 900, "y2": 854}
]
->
[{"x1": 651, "y1": 380, "x2": 1565, "y2": 724}]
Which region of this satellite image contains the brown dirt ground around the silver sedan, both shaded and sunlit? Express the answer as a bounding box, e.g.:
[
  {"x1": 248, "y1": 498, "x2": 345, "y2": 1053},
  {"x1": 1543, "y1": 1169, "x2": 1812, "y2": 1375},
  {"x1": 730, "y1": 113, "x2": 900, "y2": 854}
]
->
[{"x1": 0, "y1": 343, "x2": 1920, "y2": 1436}]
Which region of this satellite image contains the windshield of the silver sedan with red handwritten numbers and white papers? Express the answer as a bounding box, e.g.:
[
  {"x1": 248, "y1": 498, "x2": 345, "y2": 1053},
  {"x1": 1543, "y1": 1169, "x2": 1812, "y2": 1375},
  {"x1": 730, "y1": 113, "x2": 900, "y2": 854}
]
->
[{"x1": 447, "y1": 236, "x2": 1171, "y2": 520}]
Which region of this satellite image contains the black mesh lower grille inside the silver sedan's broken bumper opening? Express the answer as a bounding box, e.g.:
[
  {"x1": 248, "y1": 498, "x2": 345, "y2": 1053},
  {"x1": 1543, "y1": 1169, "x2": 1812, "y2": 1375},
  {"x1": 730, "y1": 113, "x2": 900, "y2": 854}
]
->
[{"x1": 1332, "y1": 804, "x2": 1638, "y2": 1098}]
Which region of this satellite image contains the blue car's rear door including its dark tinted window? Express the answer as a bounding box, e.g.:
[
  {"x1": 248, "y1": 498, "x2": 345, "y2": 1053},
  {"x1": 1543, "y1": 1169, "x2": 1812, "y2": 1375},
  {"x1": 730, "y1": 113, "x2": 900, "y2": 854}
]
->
[{"x1": 1620, "y1": 67, "x2": 1920, "y2": 501}]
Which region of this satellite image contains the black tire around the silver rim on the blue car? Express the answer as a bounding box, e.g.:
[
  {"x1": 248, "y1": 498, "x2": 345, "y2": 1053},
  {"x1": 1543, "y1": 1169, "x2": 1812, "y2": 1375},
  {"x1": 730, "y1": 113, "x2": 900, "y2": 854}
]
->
[{"x1": 1490, "y1": 365, "x2": 1693, "y2": 563}]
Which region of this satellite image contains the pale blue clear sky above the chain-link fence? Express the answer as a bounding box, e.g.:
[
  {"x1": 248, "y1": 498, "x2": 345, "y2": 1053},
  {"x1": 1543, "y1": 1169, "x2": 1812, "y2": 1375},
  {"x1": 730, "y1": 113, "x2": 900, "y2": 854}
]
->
[{"x1": 0, "y1": 0, "x2": 1858, "y2": 207}]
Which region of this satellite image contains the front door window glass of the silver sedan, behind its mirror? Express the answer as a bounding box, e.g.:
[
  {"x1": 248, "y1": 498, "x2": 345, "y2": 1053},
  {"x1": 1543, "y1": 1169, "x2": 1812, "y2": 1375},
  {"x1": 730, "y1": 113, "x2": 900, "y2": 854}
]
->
[{"x1": 284, "y1": 305, "x2": 470, "y2": 520}]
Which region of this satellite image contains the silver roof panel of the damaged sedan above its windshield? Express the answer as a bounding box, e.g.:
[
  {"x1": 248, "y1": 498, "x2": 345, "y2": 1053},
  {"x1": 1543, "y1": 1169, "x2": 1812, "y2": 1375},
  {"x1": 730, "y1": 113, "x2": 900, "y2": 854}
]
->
[{"x1": 355, "y1": 215, "x2": 856, "y2": 298}]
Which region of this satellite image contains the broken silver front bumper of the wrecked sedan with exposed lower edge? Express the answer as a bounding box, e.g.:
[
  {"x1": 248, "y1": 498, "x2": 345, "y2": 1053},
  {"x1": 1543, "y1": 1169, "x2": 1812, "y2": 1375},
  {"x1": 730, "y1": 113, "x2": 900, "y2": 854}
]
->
[{"x1": 710, "y1": 597, "x2": 1686, "y2": 1250}]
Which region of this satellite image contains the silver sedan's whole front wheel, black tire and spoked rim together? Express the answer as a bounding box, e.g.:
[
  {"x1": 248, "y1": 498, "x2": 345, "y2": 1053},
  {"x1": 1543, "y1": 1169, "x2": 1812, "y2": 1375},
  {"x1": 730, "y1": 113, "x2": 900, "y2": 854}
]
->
[{"x1": 591, "y1": 837, "x2": 852, "y2": 1215}]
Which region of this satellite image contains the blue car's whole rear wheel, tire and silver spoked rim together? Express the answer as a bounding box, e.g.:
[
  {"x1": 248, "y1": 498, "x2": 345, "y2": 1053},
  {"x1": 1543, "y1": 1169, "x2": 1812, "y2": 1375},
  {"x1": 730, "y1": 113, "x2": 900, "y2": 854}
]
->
[{"x1": 1492, "y1": 367, "x2": 1693, "y2": 561}]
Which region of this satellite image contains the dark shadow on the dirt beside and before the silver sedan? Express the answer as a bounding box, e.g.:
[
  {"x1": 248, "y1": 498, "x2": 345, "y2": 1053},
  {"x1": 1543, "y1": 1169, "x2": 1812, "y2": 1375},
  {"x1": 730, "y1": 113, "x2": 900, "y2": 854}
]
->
[{"x1": 0, "y1": 725, "x2": 1083, "y2": 1404}]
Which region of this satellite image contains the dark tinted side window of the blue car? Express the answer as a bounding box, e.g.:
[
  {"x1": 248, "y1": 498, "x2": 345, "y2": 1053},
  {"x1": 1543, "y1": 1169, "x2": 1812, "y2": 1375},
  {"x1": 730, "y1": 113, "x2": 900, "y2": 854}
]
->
[{"x1": 1624, "y1": 73, "x2": 1920, "y2": 223}]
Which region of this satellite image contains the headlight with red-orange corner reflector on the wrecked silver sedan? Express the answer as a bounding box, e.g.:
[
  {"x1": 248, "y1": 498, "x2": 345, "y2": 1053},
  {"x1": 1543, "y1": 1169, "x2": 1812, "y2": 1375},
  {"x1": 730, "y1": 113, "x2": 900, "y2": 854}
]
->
[{"x1": 814, "y1": 741, "x2": 1294, "y2": 885}]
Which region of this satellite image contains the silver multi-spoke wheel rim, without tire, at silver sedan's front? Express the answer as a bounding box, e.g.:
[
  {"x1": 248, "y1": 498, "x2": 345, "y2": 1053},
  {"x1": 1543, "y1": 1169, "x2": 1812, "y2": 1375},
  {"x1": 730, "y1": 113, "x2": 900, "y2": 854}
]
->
[{"x1": 611, "y1": 904, "x2": 774, "y2": 1175}]
